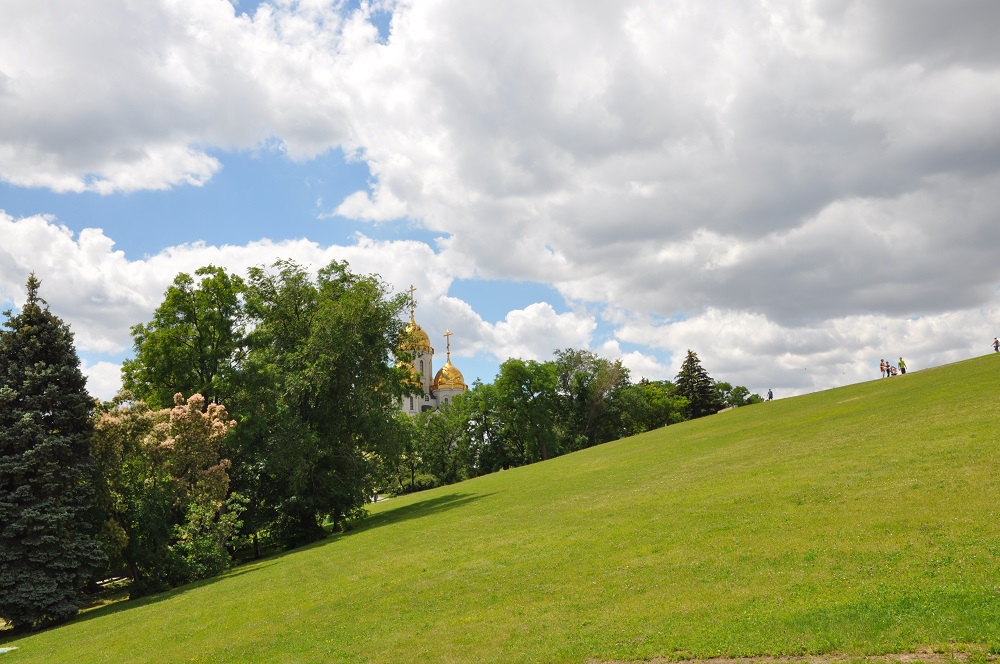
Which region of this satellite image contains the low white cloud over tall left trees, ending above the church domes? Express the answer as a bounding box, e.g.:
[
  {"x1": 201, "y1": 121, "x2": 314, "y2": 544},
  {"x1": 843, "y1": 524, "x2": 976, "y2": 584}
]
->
[{"x1": 0, "y1": 211, "x2": 451, "y2": 355}]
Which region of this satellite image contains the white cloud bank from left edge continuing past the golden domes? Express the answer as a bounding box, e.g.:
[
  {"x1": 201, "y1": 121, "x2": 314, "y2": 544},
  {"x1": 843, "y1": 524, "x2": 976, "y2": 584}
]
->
[{"x1": 0, "y1": 211, "x2": 596, "y2": 399}]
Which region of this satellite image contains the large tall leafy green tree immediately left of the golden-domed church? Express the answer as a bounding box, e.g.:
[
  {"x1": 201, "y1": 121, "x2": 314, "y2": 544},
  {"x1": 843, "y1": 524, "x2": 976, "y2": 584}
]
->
[{"x1": 234, "y1": 261, "x2": 406, "y2": 546}]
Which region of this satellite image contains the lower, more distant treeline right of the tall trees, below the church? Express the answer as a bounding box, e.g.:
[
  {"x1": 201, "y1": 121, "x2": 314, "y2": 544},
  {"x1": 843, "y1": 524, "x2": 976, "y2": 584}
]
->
[{"x1": 387, "y1": 348, "x2": 763, "y2": 493}]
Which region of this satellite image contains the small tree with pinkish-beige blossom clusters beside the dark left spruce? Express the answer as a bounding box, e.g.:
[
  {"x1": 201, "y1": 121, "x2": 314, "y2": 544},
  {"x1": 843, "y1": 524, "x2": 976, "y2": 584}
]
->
[{"x1": 91, "y1": 394, "x2": 243, "y2": 596}]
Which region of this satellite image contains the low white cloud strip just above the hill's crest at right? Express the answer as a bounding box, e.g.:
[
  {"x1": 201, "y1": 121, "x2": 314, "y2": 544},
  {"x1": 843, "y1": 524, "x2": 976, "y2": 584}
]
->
[{"x1": 617, "y1": 302, "x2": 1000, "y2": 396}]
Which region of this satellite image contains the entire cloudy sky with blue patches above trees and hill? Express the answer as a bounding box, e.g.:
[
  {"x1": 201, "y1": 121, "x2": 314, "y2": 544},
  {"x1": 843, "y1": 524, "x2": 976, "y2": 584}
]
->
[{"x1": 0, "y1": 0, "x2": 1000, "y2": 399}]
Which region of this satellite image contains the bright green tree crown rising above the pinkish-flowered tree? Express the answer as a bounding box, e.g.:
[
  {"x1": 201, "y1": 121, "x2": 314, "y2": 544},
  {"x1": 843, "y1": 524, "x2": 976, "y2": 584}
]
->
[{"x1": 122, "y1": 265, "x2": 244, "y2": 409}]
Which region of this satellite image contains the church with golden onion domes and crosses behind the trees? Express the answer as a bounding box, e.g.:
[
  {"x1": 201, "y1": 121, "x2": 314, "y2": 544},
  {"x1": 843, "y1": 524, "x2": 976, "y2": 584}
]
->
[{"x1": 399, "y1": 286, "x2": 469, "y2": 416}]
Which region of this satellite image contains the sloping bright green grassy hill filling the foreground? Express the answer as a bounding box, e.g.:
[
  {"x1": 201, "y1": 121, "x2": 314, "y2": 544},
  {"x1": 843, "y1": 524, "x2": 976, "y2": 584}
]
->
[{"x1": 0, "y1": 355, "x2": 1000, "y2": 664}]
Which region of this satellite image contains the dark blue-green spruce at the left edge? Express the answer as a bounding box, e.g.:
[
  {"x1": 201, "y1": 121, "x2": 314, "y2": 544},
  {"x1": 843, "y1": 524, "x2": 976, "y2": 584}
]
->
[{"x1": 0, "y1": 274, "x2": 104, "y2": 630}]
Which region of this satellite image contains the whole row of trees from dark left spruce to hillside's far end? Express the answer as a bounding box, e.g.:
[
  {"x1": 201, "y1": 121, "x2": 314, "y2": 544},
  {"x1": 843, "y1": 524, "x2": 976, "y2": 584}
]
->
[{"x1": 0, "y1": 261, "x2": 759, "y2": 630}]
